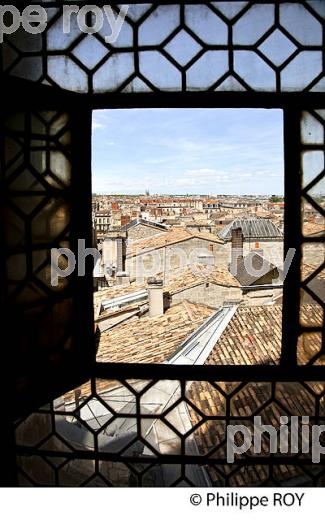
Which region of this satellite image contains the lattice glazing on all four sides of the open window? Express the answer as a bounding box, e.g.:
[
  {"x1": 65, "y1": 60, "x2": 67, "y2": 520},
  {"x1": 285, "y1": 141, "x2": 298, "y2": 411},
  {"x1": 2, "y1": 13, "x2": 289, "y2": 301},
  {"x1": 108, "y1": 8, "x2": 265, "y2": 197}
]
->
[{"x1": 1, "y1": 0, "x2": 325, "y2": 486}]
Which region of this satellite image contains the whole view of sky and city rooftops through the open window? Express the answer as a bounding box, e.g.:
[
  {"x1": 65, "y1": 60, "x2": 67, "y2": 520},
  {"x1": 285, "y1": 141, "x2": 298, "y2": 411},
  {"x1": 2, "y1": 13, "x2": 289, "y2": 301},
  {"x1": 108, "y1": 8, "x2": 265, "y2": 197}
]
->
[{"x1": 92, "y1": 109, "x2": 290, "y2": 364}]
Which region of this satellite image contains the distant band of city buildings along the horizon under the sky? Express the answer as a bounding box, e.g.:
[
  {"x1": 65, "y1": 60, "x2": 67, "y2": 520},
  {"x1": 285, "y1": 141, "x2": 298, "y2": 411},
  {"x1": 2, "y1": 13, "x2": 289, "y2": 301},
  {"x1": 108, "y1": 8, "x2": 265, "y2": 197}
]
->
[{"x1": 93, "y1": 195, "x2": 284, "y2": 240}]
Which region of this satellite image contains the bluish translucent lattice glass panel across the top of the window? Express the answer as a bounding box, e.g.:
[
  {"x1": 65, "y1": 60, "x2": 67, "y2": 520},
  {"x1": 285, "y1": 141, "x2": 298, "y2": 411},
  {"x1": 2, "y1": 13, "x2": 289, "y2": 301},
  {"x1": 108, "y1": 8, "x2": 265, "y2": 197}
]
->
[{"x1": 2, "y1": 1, "x2": 325, "y2": 93}]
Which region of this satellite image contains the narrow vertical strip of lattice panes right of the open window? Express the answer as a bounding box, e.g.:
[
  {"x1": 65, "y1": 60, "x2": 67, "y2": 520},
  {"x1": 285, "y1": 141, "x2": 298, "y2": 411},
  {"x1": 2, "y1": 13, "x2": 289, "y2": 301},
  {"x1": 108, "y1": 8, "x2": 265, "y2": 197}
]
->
[{"x1": 299, "y1": 110, "x2": 325, "y2": 365}]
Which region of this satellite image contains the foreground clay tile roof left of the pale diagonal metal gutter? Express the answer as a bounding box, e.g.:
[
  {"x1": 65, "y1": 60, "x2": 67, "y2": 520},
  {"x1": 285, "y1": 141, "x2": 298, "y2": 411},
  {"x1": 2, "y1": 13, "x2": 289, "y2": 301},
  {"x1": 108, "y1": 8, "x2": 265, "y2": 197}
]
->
[{"x1": 97, "y1": 301, "x2": 215, "y2": 363}]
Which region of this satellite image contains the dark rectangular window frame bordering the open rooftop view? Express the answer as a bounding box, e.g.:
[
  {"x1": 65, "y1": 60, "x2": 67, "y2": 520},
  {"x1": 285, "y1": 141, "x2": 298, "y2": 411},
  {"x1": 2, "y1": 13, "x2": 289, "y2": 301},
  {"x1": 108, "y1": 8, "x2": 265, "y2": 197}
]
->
[{"x1": 4, "y1": 79, "x2": 325, "y2": 410}]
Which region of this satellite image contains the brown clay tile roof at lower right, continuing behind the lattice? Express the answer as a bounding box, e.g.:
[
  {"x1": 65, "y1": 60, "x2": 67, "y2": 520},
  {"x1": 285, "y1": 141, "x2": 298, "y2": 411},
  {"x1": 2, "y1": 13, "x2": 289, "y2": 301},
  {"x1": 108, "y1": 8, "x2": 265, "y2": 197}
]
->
[{"x1": 188, "y1": 305, "x2": 322, "y2": 486}]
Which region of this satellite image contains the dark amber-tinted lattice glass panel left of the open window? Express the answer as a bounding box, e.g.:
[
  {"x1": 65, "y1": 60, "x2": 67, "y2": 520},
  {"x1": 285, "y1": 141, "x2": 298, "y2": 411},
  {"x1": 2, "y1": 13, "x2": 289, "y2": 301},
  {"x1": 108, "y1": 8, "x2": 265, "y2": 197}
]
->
[{"x1": 1, "y1": 110, "x2": 91, "y2": 414}]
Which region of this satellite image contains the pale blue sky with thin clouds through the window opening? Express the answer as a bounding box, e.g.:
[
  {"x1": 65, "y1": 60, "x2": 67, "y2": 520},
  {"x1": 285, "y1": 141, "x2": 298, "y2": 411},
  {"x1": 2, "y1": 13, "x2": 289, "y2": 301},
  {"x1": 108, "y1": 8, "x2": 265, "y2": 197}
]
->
[{"x1": 92, "y1": 109, "x2": 284, "y2": 195}]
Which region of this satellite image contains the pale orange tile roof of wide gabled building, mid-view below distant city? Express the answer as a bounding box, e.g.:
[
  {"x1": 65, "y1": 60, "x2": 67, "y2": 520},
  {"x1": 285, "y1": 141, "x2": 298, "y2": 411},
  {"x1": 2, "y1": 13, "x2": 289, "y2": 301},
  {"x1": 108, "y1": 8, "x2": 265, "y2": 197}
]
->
[{"x1": 126, "y1": 227, "x2": 224, "y2": 257}]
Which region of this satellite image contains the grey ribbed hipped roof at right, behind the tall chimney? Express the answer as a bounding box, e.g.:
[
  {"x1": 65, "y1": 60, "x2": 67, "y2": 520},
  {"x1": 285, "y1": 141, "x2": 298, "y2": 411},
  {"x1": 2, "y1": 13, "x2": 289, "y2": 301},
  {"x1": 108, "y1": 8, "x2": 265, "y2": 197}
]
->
[{"x1": 219, "y1": 218, "x2": 283, "y2": 241}]
